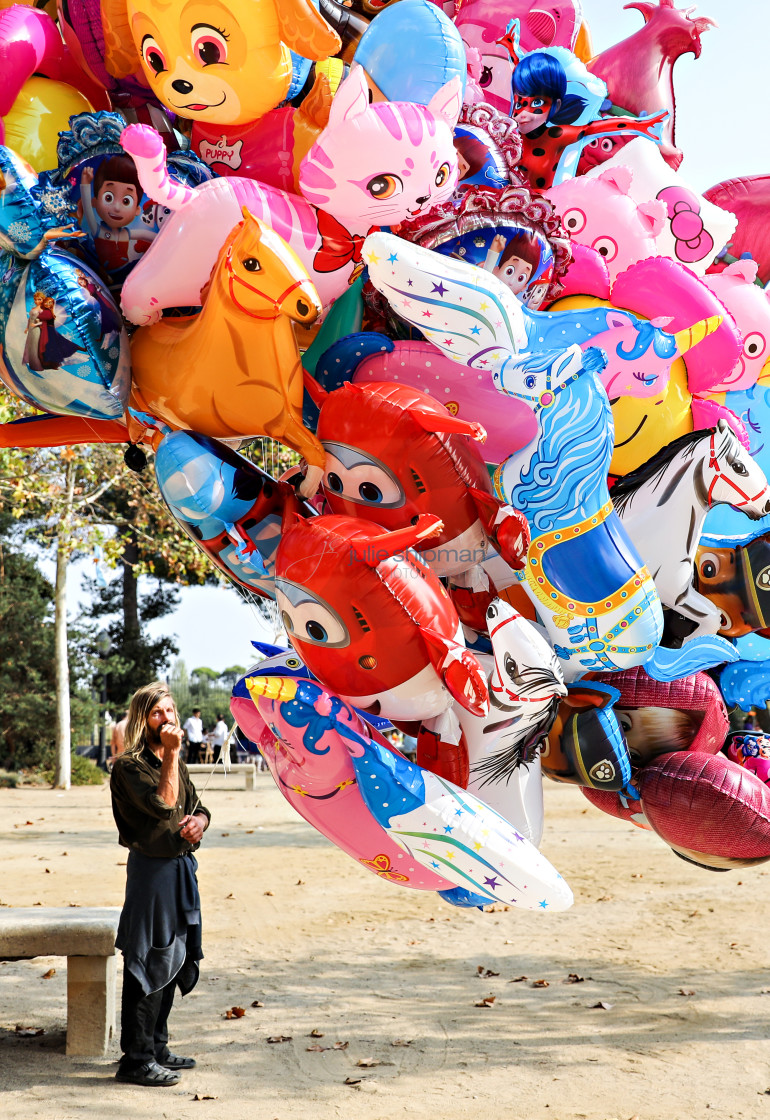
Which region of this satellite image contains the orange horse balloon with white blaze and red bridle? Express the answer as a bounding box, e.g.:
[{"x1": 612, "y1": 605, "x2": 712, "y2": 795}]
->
[{"x1": 129, "y1": 208, "x2": 325, "y2": 496}]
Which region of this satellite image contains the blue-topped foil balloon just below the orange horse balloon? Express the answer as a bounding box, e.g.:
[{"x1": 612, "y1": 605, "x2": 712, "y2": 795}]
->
[{"x1": 156, "y1": 431, "x2": 316, "y2": 599}]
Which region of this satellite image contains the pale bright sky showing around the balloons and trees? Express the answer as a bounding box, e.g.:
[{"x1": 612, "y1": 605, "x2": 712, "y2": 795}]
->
[{"x1": 44, "y1": 0, "x2": 770, "y2": 671}]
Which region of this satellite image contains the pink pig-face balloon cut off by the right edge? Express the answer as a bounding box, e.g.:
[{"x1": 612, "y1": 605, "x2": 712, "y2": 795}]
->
[{"x1": 703, "y1": 261, "x2": 770, "y2": 392}]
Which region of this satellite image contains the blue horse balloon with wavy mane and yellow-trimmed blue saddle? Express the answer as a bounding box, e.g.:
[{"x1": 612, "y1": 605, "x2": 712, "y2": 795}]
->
[{"x1": 495, "y1": 349, "x2": 663, "y2": 680}]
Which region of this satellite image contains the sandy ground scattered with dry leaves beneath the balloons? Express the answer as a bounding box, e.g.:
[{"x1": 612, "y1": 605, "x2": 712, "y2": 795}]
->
[{"x1": 0, "y1": 775, "x2": 770, "y2": 1120}]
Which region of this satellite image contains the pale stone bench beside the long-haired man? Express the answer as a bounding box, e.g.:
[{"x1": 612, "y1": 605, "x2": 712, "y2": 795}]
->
[{"x1": 0, "y1": 906, "x2": 121, "y2": 1056}]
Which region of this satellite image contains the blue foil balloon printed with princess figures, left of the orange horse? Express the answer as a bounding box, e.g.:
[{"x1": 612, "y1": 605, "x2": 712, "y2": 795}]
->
[{"x1": 0, "y1": 248, "x2": 131, "y2": 420}]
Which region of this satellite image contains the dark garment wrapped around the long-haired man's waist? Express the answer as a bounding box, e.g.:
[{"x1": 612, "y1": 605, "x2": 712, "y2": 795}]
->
[{"x1": 115, "y1": 851, "x2": 204, "y2": 996}]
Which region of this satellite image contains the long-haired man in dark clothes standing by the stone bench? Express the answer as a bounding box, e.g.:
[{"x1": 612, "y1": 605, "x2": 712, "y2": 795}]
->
[{"x1": 110, "y1": 682, "x2": 210, "y2": 1085}]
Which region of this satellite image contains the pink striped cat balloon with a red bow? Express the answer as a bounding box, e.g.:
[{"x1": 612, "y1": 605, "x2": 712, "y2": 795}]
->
[{"x1": 121, "y1": 66, "x2": 462, "y2": 325}]
